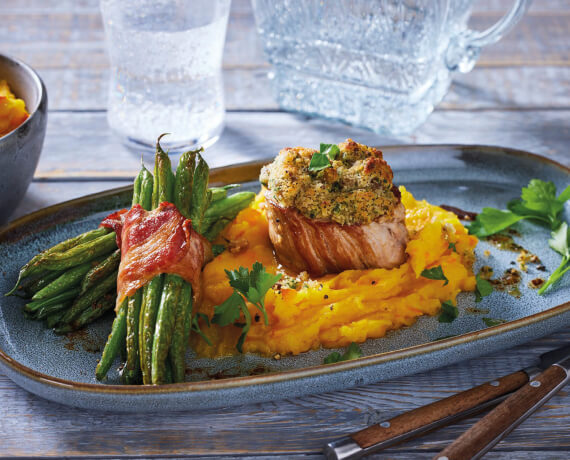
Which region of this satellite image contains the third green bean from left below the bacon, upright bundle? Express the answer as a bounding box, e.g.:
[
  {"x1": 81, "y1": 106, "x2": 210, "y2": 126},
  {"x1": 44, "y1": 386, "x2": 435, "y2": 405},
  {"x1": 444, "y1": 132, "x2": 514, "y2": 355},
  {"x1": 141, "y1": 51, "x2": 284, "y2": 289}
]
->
[{"x1": 139, "y1": 275, "x2": 164, "y2": 385}]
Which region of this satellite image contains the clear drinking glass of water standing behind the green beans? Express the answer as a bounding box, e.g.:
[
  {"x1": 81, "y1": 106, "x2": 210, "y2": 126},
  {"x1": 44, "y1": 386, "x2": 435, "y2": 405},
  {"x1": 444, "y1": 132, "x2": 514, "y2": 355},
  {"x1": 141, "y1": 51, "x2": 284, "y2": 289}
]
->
[{"x1": 100, "y1": 0, "x2": 231, "y2": 155}]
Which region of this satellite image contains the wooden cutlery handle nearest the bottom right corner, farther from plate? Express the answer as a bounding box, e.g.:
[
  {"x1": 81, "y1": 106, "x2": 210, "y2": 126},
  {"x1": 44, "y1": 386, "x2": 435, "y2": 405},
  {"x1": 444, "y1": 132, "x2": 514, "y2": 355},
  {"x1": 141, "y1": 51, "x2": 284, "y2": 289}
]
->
[{"x1": 434, "y1": 358, "x2": 570, "y2": 460}]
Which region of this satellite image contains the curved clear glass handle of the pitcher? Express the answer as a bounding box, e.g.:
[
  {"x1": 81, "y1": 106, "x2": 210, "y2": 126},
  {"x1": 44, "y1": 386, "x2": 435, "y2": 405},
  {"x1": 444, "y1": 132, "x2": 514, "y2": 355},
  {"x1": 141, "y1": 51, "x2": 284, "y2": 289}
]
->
[{"x1": 445, "y1": 0, "x2": 532, "y2": 73}]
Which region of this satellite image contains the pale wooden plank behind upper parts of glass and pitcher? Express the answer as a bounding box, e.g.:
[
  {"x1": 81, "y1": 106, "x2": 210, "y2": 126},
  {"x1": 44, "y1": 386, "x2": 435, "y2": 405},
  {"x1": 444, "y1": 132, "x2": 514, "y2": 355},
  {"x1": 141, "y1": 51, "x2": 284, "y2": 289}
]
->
[{"x1": 0, "y1": 9, "x2": 569, "y2": 69}]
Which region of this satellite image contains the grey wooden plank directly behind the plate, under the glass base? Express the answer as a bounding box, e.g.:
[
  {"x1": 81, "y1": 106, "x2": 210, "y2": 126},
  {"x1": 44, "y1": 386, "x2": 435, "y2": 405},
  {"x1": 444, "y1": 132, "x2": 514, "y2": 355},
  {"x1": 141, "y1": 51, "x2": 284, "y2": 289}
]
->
[{"x1": 30, "y1": 110, "x2": 570, "y2": 180}]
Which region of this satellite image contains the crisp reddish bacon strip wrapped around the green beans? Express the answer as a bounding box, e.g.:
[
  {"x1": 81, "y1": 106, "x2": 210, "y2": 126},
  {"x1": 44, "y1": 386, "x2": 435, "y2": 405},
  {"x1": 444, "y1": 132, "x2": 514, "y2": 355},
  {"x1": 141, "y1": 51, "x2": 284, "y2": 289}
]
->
[{"x1": 101, "y1": 202, "x2": 211, "y2": 305}]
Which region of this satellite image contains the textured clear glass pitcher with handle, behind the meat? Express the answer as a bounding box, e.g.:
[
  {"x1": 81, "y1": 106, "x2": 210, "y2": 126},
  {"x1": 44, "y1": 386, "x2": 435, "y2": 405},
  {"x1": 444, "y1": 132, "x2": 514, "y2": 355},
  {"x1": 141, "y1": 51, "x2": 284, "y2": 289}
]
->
[{"x1": 253, "y1": 0, "x2": 530, "y2": 134}]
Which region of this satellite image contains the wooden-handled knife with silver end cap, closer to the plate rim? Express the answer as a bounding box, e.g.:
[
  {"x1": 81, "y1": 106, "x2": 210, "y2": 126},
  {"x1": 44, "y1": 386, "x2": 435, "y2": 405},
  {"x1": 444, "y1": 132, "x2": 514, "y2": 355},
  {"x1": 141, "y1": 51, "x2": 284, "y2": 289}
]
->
[{"x1": 323, "y1": 345, "x2": 570, "y2": 460}]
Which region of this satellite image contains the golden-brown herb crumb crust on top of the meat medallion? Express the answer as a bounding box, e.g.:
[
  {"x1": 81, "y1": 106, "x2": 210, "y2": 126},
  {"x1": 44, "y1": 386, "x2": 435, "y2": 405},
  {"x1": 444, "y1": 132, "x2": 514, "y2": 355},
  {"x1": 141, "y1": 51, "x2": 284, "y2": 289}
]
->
[{"x1": 260, "y1": 139, "x2": 400, "y2": 225}]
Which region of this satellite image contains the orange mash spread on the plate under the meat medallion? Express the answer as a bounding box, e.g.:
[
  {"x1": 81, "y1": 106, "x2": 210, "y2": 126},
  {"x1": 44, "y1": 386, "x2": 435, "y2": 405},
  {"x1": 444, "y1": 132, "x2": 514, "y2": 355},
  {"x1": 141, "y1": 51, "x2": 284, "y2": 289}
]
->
[{"x1": 192, "y1": 187, "x2": 477, "y2": 357}]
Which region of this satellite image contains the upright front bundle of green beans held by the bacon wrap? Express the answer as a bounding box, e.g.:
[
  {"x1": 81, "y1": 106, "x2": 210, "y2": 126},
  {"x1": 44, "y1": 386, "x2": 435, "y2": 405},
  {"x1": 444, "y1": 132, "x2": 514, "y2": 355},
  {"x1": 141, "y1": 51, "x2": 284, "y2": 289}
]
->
[{"x1": 95, "y1": 143, "x2": 254, "y2": 385}]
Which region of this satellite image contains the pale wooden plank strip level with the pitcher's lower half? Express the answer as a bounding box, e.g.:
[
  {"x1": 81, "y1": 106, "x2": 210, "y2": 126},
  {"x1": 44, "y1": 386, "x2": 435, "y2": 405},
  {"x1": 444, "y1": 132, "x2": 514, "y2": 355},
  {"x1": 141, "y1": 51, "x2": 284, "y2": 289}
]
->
[{"x1": 24, "y1": 66, "x2": 570, "y2": 110}]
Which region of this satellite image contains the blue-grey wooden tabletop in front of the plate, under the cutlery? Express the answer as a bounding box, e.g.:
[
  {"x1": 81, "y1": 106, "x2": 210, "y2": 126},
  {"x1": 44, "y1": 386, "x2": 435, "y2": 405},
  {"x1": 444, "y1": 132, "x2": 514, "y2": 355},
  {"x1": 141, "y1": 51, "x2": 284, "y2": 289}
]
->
[{"x1": 0, "y1": 331, "x2": 570, "y2": 458}]
